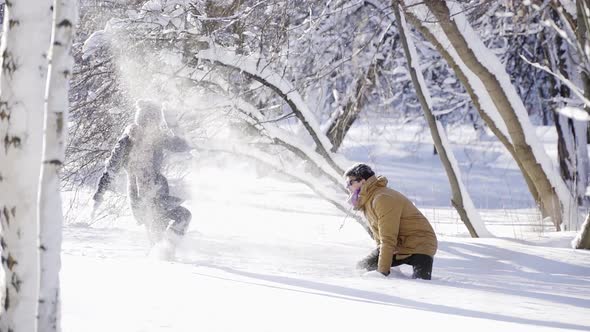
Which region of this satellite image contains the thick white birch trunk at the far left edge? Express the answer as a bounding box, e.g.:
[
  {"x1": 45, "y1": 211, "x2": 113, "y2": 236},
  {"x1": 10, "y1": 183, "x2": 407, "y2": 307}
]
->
[{"x1": 0, "y1": 0, "x2": 52, "y2": 332}]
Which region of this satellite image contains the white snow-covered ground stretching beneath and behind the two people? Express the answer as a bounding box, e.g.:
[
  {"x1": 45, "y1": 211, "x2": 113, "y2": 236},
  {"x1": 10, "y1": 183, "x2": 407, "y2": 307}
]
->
[{"x1": 61, "y1": 125, "x2": 590, "y2": 332}]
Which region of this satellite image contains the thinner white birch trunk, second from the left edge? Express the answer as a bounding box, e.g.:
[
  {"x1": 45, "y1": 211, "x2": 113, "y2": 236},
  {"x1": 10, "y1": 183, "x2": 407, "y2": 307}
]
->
[{"x1": 37, "y1": 0, "x2": 78, "y2": 332}]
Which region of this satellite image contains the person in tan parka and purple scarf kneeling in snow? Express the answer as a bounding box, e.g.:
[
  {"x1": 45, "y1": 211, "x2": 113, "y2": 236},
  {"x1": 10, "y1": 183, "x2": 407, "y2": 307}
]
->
[{"x1": 344, "y1": 164, "x2": 437, "y2": 280}]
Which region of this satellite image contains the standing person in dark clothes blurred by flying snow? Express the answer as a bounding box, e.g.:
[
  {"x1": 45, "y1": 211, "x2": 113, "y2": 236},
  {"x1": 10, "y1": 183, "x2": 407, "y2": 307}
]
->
[{"x1": 93, "y1": 100, "x2": 191, "y2": 255}]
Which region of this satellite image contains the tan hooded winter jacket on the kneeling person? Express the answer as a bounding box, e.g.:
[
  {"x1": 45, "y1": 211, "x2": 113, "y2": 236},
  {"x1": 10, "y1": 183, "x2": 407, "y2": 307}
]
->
[{"x1": 356, "y1": 176, "x2": 437, "y2": 274}]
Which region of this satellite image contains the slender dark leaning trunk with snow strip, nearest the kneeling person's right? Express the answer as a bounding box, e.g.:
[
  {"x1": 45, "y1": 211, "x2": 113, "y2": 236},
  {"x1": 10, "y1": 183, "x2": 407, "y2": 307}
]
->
[{"x1": 392, "y1": 0, "x2": 491, "y2": 237}]
